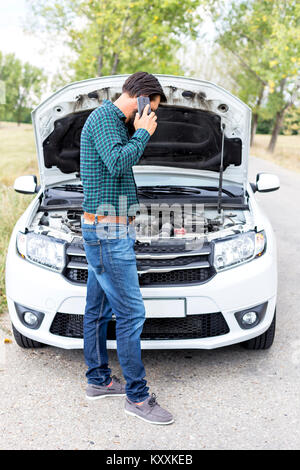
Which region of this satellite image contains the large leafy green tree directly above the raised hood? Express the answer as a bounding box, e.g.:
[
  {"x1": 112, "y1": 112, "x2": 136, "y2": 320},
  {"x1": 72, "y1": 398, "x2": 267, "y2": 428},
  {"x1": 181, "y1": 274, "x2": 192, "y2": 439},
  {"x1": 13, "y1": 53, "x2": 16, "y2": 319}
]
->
[{"x1": 28, "y1": 0, "x2": 208, "y2": 80}]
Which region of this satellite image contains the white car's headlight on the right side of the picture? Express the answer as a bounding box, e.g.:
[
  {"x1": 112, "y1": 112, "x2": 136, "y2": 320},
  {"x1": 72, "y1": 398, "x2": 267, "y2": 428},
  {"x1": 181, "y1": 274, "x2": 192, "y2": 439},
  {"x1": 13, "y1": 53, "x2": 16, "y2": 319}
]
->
[{"x1": 214, "y1": 231, "x2": 266, "y2": 271}]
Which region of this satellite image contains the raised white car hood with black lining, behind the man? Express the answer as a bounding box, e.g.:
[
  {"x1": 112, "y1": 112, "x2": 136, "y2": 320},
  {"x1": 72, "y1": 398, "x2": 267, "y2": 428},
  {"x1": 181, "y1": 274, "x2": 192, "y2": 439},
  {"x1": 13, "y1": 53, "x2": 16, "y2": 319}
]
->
[{"x1": 32, "y1": 74, "x2": 251, "y2": 187}]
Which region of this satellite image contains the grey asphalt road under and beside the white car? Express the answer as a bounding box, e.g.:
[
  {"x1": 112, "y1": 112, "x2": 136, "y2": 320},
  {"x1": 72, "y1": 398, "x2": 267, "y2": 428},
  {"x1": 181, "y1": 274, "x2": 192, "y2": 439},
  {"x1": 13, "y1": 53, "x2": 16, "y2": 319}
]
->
[{"x1": 0, "y1": 157, "x2": 300, "y2": 450}]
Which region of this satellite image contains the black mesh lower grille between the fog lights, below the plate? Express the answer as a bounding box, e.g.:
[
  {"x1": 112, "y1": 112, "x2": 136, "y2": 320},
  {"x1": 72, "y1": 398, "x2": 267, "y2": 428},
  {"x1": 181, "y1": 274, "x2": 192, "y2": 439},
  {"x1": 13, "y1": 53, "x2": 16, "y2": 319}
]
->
[{"x1": 50, "y1": 312, "x2": 229, "y2": 340}]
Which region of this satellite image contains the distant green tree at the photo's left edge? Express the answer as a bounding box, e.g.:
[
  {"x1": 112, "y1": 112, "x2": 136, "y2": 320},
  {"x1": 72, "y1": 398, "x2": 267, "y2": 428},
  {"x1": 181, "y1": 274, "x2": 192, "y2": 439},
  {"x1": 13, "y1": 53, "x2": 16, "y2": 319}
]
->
[{"x1": 0, "y1": 52, "x2": 47, "y2": 125}]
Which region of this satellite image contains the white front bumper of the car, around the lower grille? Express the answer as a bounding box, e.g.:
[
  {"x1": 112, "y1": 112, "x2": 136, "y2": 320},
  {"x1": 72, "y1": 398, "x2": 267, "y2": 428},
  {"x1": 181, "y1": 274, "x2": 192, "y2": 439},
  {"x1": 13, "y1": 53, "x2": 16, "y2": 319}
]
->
[{"x1": 6, "y1": 231, "x2": 277, "y2": 349}]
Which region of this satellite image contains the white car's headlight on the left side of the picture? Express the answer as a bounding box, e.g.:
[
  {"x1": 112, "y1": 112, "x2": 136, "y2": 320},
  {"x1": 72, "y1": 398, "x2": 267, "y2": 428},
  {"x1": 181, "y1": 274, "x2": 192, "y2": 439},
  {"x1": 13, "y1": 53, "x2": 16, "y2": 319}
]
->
[{"x1": 17, "y1": 232, "x2": 65, "y2": 272}]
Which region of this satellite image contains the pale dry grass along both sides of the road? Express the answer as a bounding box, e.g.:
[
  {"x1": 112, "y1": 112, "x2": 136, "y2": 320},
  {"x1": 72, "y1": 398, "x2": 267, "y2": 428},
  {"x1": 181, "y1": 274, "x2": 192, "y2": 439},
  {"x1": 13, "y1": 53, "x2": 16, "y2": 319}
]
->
[{"x1": 0, "y1": 122, "x2": 300, "y2": 313}]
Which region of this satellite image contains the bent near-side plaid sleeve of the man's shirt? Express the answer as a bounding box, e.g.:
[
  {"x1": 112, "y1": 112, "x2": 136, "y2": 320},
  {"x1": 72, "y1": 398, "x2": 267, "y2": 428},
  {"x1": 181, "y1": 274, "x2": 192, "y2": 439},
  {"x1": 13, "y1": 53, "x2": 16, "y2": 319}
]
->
[{"x1": 90, "y1": 114, "x2": 151, "y2": 176}]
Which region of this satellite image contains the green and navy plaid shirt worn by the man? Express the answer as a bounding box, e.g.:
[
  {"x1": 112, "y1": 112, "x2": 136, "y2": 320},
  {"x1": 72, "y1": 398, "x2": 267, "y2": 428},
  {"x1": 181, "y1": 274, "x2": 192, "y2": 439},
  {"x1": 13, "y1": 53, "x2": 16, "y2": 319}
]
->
[{"x1": 80, "y1": 99, "x2": 150, "y2": 215}]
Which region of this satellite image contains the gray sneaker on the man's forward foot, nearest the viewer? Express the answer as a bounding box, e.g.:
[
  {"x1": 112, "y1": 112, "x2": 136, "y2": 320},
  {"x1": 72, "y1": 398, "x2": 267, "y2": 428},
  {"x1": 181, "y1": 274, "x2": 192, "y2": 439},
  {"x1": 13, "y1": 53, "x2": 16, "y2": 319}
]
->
[{"x1": 125, "y1": 393, "x2": 174, "y2": 424}]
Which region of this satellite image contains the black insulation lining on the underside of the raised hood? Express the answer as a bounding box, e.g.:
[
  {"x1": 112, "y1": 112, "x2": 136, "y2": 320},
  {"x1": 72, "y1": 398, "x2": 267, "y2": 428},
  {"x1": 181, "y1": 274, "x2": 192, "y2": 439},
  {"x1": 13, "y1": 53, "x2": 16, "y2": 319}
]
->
[{"x1": 43, "y1": 104, "x2": 242, "y2": 173}]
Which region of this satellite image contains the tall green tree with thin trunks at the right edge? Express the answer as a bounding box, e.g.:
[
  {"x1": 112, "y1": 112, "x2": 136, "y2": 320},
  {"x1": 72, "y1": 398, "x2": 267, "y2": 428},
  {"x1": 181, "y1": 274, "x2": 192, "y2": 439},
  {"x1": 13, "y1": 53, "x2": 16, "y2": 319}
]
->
[{"x1": 211, "y1": 0, "x2": 300, "y2": 152}]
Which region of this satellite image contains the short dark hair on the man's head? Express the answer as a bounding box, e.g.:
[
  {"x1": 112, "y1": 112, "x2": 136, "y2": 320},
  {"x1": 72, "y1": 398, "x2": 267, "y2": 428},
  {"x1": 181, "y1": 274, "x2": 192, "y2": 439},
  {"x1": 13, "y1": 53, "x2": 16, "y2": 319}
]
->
[{"x1": 122, "y1": 72, "x2": 167, "y2": 103}]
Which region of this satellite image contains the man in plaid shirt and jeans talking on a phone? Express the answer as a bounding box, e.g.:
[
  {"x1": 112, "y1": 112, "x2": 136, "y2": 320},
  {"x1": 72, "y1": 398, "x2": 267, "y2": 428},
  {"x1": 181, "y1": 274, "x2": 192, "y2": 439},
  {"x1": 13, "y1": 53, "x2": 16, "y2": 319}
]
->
[{"x1": 80, "y1": 72, "x2": 174, "y2": 424}]
